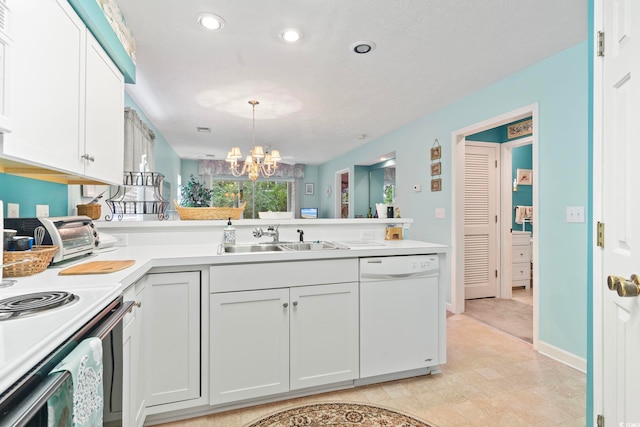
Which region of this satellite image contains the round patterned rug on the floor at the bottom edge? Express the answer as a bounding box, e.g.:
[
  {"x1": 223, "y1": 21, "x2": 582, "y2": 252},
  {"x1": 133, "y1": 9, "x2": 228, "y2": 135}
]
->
[{"x1": 246, "y1": 403, "x2": 435, "y2": 427}]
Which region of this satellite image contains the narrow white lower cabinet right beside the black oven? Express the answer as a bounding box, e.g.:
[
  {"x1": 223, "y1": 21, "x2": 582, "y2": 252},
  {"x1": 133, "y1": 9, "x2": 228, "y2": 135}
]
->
[{"x1": 121, "y1": 278, "x2": 147, "y2": 427}]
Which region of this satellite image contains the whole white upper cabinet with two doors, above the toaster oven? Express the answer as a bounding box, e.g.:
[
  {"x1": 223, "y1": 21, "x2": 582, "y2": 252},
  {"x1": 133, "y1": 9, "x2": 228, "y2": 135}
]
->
[{"x1": 2, "y1": 0, "x2": 124, "y2": 184}]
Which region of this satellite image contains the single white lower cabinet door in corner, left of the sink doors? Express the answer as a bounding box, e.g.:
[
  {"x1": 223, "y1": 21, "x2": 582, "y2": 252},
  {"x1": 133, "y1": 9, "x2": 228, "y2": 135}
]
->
[{"x1": 146, "y1": 271, "x2": 201, "y2": 406}]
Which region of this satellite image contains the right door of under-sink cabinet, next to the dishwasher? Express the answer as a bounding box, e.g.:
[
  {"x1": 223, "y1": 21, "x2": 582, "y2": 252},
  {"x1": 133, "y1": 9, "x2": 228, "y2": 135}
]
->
[{"x1": 290, "y1": 282, "x2": 359, "y2": 390}]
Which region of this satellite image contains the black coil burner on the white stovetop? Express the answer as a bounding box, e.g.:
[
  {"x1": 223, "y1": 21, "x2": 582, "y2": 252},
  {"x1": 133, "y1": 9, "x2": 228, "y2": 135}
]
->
[{"x1": 0, "y1": 291, "x2": 79, "y2": 320}]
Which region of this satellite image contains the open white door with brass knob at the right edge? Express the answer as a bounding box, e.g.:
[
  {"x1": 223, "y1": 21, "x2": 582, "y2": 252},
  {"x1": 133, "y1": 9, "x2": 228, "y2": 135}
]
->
[{"x1": 594, "y1": 0, "x2": 640, "y2": 426}]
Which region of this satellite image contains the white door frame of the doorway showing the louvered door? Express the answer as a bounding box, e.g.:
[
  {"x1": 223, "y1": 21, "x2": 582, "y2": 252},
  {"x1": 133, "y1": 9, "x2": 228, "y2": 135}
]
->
[{"x1": 447, "y1": 102, "x2": 540, "y2": 350}]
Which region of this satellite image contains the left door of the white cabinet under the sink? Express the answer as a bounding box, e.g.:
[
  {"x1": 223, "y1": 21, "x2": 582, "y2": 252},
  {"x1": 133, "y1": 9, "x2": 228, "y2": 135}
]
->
[{"x1": 210, "y1": 288, "x2": 289, "y2": 405}]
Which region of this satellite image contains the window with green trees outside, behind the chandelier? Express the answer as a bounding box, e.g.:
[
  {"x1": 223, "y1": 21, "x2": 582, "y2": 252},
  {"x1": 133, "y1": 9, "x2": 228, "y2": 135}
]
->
[{"x1": 211, "y1": 179, "x2": 294, "y2": 219}]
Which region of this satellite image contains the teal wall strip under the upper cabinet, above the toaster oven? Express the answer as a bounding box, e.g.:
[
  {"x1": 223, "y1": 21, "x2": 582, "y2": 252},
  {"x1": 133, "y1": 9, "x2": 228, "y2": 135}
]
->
[{"x1": 0, "y1": 174, "x2": 69, "y2": 218}]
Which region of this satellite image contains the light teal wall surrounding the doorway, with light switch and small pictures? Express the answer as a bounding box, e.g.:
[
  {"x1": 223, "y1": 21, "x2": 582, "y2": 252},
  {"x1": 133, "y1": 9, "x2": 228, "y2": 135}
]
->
[{"x1": 320, "y1": 41, "x2": 589, "y2": 358}]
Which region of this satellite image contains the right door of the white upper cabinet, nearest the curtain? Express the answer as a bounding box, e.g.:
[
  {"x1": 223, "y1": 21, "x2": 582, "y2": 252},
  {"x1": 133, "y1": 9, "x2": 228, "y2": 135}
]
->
[{"x1": 84, "y1": 31, "x2": 124, "y2": 184}]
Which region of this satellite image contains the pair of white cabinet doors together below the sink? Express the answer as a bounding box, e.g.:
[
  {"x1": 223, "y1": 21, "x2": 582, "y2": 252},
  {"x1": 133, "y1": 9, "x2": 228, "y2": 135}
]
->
[{"x1": 210, "y1": 282, "x2": 358, "y2": 405}]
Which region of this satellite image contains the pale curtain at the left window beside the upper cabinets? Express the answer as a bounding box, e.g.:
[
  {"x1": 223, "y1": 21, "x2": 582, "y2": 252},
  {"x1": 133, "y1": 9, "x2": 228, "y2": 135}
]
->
[{"x1": 124, "y1": 107, "x2": 156, "y2": 172}]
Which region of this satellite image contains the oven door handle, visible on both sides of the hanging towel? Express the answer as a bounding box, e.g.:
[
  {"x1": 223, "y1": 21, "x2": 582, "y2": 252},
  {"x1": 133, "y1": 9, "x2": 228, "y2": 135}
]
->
[{"x1": 0, "y1": 301, "x2": 136, "y2": 427}]
